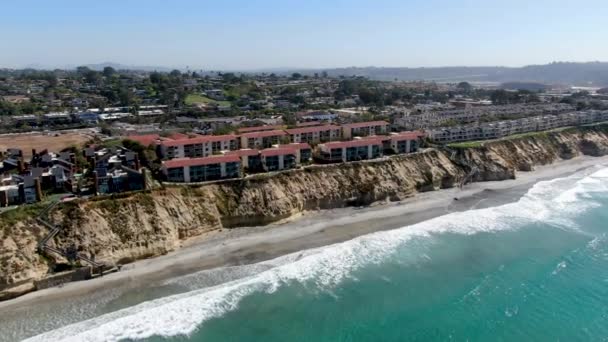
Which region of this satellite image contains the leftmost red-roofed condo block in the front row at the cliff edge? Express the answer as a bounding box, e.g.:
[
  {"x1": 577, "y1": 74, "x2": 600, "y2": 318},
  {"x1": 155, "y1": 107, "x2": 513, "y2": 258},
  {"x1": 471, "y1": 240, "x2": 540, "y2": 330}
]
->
[{"x1": 161, "y1": 155, "x2": 241, "y2": 183}]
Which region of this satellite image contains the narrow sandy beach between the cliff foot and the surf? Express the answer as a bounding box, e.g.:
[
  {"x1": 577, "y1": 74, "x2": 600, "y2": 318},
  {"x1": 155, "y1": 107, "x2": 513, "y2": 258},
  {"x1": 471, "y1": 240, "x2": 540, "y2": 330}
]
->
[{"x1": 0, "y1": 157, "x2": 608, "y2": 315}]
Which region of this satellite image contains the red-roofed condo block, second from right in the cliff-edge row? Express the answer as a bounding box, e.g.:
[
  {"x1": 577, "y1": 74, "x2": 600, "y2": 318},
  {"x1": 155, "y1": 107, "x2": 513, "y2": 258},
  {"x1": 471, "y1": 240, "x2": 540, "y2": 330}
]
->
[{"x1": 317, "y1": 138, "x2": 383, "y2": 162}]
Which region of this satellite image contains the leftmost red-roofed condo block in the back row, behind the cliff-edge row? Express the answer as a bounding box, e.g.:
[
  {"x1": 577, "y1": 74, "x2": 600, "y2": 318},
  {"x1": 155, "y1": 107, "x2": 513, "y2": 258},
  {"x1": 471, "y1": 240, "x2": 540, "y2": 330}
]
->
[{"x1": 160, "y1": 134, "x2": 238, "y2": 159}]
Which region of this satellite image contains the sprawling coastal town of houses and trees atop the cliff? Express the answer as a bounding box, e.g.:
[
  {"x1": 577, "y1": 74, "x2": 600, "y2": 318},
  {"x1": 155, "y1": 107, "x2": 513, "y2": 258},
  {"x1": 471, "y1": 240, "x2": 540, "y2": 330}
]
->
[{"x1": 0, "y1": 67, "x2": 608, "y2": 207}]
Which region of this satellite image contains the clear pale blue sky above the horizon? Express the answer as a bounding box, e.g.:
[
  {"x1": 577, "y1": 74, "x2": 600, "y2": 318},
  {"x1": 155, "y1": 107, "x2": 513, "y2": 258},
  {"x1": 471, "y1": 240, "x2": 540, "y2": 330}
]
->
[{"x1": 0, "y1": 0, "x2": 608, "y2": 70}]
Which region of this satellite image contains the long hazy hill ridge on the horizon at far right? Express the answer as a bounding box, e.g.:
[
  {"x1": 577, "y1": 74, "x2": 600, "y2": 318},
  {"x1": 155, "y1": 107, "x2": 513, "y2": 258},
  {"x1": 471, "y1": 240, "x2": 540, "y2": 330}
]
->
[{"x1": 299, "y1": 62, "x2": 608, "y2": 86}]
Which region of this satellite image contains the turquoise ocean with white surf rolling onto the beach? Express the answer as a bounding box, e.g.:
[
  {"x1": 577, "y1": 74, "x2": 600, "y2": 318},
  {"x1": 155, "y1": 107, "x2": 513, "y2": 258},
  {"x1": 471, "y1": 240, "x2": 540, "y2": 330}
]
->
[{"x1": 7, "y1": 167, "x2": 608, "y2": 341}]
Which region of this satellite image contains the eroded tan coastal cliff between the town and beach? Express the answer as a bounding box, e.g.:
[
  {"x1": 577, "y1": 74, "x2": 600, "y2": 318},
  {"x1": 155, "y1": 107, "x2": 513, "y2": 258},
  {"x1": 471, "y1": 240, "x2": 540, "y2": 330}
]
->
[{"x1": 0, "y1": 125, "x2": 608, "y2": 299}]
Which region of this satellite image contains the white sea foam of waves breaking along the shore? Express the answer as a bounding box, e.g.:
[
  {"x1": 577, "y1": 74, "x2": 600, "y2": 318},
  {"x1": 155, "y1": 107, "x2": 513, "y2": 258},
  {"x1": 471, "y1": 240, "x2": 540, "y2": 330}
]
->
[{"x1": 23, "y1": 169, "x2": 608, "y2": 341}]
